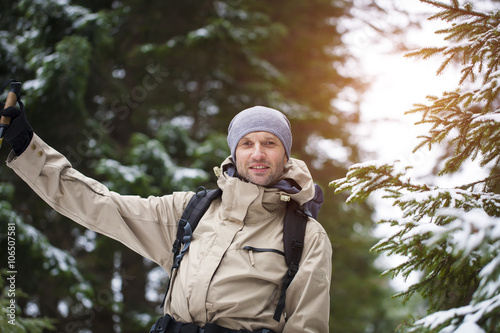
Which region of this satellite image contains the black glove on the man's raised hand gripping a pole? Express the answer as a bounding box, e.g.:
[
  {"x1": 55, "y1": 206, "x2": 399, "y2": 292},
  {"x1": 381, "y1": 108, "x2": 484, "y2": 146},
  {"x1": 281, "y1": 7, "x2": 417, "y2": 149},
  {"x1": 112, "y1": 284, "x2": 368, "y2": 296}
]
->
[{"x1": 0, "y1": 103, "x2": 33, "y2": 156}]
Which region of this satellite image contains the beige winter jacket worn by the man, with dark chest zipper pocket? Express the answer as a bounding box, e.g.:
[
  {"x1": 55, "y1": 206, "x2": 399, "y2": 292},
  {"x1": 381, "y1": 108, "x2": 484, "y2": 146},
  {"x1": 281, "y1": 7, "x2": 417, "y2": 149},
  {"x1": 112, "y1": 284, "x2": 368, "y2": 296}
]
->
[{"x1": 7, "y1": 134, "x2": 332, "y2": 333}]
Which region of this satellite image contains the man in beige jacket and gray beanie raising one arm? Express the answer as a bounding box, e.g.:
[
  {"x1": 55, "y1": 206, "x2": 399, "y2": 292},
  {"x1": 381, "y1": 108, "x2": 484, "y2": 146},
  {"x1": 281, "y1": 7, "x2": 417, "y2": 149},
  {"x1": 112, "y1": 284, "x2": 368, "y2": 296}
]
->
[{"x1": 0, "y1": 106, "x2": 332, "y2": 333}]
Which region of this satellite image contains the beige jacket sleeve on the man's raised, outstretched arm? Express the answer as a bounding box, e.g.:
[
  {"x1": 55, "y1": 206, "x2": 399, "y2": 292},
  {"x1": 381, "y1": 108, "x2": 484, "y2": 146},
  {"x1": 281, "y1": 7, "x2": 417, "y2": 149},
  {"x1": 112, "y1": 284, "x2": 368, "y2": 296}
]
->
[{"x1": 7, "y1": 134, "x2": 190, "y2": 268}]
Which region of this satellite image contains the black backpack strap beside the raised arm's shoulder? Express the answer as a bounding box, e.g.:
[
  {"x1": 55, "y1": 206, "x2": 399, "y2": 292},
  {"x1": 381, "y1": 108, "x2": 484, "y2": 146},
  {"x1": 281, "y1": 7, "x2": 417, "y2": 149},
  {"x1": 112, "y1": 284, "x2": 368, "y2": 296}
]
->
[{"x1": 160, "y1": 186, "x2": 222, "y2": 307}]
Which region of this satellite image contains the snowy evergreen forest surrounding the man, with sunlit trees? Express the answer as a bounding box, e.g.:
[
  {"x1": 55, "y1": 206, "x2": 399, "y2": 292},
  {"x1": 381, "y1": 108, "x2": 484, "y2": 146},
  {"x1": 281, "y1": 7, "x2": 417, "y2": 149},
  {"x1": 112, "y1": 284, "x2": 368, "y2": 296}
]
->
[{"x1": 0, "y1": 0, "x2": 500, "y2": 333}]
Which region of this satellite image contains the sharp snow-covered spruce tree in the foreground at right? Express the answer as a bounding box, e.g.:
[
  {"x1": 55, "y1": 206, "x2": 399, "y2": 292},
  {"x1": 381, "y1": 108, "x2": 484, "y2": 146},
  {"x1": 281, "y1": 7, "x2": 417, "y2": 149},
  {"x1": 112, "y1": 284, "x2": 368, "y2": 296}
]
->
[{"x1": 331, "y1": 0, "x2": 500, "y2": 333}]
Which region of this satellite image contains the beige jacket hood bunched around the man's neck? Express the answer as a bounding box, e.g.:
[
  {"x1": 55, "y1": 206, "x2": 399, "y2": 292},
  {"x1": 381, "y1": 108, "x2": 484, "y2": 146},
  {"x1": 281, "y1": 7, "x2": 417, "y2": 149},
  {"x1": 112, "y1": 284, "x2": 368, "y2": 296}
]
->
[{"x1": 215, "y1": 156, "x2": 324, "y2": 218}]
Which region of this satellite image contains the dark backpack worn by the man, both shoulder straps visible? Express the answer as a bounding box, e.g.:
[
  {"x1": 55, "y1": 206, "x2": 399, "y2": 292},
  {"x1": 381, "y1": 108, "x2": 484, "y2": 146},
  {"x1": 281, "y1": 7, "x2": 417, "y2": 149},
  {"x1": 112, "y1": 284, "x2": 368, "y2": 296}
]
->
[{"x1": 161, "y1": 185, "x2": 323, "y2": 321}]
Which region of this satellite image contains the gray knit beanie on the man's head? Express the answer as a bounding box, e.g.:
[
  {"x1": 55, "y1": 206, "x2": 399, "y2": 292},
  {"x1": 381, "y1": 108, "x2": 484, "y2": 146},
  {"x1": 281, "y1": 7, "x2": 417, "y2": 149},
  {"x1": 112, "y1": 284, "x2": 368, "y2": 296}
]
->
[{"x1": 227, "y1": 106, "x2": 292, "y2": 161}]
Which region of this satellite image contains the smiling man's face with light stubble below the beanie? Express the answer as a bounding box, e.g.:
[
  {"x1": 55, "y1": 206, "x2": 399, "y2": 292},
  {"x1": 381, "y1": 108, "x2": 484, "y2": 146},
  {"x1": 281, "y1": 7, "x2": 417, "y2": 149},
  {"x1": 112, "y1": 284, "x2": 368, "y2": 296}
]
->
[{"x1": 235, "y1": 132, "x2": 287, "y2": 186}]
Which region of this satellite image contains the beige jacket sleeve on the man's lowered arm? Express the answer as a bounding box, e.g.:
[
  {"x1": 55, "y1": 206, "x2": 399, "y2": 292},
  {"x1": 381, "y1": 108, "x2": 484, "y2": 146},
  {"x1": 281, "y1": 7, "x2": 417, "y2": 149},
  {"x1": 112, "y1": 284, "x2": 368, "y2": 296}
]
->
[{"x1": 283, "y1": 219, "x2": 332, "y2": 333}]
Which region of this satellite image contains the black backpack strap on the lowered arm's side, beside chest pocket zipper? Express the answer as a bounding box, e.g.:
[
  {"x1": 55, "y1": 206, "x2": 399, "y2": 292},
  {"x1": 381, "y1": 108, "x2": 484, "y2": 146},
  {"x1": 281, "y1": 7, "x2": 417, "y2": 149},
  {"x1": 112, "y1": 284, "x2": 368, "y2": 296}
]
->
[{"x1": 273, "y1": 200, "x2": 308, "y2": 322}]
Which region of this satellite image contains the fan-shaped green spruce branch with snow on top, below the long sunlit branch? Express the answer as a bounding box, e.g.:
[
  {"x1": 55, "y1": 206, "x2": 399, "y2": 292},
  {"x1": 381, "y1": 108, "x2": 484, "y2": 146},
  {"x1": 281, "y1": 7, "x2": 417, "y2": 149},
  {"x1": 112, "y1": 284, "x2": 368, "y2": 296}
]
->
[{"x1": 372, "y1": 202, "x2": 500, "y2": 311}]
